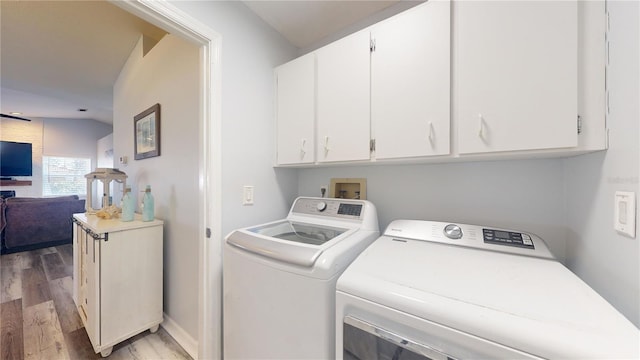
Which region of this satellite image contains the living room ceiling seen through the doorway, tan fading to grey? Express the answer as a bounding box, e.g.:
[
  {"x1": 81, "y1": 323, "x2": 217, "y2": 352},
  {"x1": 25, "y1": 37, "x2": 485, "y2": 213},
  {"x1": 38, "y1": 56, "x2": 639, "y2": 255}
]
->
[{"x1": 0, "y1": 0, "x2": 165, "y2": 123}]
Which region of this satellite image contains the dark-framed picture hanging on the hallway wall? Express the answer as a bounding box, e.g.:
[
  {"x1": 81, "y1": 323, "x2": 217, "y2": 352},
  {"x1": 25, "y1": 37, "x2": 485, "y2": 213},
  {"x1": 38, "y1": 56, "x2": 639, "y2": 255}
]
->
[{"x1": 133, "y1": 104, "x2": 160, "y2": 160}]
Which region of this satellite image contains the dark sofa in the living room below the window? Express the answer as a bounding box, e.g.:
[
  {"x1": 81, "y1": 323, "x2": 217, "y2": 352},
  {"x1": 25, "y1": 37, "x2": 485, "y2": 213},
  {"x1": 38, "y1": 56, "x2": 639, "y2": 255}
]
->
[{"x1": 0, "y1": 195, "x2": 85, "y2": 254}]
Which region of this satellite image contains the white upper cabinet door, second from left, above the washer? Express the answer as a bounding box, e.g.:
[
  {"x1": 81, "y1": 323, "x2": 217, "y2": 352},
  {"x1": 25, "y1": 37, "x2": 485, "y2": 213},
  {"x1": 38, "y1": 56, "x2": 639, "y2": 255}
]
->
[{"x1": 316, "y1": 30, "x2": 371, "y2": 162}]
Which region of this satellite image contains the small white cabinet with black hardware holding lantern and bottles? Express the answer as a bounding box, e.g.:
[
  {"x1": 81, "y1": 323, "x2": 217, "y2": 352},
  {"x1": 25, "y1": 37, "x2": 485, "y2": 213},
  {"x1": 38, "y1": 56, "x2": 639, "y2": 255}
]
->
[{"x1": 73, "y1": 214, "x2": 163, "y2": 357}]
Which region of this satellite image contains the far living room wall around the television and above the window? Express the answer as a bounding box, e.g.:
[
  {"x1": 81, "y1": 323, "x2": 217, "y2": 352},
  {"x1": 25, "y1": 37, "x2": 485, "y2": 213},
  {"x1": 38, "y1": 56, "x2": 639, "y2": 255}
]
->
[{"x1": 0, "y1": 118, "x2": 113, "y2": 197}]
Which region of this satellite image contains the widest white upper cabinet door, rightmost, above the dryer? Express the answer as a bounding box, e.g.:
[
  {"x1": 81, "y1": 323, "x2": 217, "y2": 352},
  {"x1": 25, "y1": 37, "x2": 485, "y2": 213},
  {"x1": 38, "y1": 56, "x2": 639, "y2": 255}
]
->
[{"x1": 453, "y1": 1, "x2": 578, "y2": 154}]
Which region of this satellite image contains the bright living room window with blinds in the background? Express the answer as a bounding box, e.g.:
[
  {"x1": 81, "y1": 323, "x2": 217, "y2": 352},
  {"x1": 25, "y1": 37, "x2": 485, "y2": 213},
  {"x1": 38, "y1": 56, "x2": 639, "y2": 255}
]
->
[{"x1": 42, "y1": 156, "x2": 91, "y2": 196}]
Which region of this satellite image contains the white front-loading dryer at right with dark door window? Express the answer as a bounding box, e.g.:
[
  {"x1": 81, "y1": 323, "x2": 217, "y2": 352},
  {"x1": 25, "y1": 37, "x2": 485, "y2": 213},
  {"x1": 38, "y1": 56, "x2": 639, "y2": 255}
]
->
[{"x1": 336, "y1": 220, "x2": 640, "y2": 360}]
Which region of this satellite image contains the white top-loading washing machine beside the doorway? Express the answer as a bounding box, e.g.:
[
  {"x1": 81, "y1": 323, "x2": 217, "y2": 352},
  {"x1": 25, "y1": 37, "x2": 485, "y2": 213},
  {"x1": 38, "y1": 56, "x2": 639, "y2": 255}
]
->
[{"x1": 223, "y1": 197, "x2": 380, "y2": 359}]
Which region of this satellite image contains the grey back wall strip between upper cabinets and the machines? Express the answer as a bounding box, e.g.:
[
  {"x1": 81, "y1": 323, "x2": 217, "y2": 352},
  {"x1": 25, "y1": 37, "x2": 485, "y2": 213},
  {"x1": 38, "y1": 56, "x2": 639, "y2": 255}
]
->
[{"x1": 299, "y1": 160, "x2": 565, "y2": 261}]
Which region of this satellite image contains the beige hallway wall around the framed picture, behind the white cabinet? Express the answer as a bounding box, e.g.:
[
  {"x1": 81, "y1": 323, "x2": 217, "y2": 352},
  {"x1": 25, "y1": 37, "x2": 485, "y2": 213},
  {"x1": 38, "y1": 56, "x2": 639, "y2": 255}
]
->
[{"x1": 113, "y1": 35, "x2": 200, "y2": 339}]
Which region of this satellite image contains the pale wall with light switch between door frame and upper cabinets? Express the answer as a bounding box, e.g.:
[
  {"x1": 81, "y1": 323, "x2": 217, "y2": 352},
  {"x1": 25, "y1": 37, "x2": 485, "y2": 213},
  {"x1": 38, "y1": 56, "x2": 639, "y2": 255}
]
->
[{"x1": 173, "y1": 1, "x2": 298, "y2": 235}]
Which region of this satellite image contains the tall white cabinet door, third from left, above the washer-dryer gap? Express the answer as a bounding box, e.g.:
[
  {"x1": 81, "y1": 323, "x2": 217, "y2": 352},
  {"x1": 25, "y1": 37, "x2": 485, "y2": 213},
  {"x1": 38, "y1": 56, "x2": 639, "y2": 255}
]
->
[{"x1": 371, "y1": 1, "x2": 451, "y2": 159}]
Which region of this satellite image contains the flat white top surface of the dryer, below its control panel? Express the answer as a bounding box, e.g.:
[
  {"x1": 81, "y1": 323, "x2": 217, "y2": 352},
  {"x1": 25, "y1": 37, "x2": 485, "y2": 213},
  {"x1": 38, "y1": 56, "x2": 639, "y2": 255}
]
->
[{"x1": 337, "y1": 232, "x2": 640, "y2": 358}]
